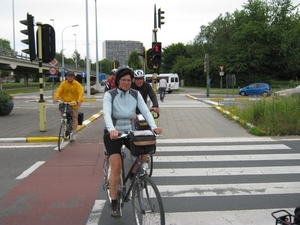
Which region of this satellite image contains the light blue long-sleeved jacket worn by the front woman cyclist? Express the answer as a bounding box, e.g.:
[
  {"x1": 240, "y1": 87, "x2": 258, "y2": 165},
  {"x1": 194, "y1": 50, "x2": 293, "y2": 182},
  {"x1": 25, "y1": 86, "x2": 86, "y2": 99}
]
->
[{"x1": 103, "y1": 88, "x2": 157, "y2": 133}]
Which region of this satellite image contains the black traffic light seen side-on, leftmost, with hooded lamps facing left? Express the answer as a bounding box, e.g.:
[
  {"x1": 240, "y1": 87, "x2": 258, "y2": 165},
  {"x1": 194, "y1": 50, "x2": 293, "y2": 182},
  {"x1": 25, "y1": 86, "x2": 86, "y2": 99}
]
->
[{"x1": 20, "y1": 13, "x2": 36, "y2": 62}]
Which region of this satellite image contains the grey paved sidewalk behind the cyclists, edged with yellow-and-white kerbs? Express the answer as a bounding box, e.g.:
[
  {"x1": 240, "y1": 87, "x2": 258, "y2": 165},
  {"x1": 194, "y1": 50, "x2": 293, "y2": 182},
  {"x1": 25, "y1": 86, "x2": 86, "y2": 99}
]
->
[{"x1": 0, "y1": 88, "x2": 253, "y2": 142}]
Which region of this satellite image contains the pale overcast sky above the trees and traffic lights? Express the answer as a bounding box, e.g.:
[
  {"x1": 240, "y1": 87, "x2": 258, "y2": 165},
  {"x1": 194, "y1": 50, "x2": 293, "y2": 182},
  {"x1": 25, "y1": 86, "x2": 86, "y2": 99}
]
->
[{"x1": 0, "y1": 0, "x2": 300, "y2": 62}]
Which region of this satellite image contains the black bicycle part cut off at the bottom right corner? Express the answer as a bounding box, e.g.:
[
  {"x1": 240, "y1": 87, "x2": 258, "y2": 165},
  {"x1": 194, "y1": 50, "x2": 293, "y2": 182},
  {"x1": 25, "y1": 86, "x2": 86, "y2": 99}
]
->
[{"x1": 271, "y1": 207, "x2": 300, "y2": 225}]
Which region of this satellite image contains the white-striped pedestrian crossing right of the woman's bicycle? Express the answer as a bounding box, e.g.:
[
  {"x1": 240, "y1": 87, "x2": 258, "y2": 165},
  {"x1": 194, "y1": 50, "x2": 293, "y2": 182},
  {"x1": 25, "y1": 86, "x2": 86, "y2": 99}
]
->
[{"x1": 89, "y1": 138, "x2": 300, "y2": 225}]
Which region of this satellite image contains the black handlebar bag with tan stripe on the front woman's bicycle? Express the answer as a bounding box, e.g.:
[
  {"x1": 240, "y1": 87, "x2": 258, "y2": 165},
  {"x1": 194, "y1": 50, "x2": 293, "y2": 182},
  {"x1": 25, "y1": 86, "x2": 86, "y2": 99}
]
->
[{"x1": 130, "y1": 130, "x2": 156, "y2": 156}]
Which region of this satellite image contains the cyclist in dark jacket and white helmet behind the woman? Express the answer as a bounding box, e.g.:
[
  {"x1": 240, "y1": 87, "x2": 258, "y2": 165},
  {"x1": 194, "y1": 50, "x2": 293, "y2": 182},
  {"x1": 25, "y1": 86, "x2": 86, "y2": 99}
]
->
[{"x1": 131, "y1": 70, "x2": 159, "y2": 114}]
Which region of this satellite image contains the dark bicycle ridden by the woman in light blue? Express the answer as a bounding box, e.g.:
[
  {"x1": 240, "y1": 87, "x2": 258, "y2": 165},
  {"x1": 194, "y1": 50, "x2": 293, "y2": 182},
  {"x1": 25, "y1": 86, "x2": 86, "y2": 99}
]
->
[{"x1": 103, "y1": 134, "x2": 165, "y2": 225}]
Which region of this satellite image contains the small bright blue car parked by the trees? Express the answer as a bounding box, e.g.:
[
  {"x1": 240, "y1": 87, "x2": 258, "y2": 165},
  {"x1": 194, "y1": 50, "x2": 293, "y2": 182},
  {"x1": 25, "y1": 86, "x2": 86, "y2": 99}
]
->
[{"x1": 239, "y1": 83, "x2": 272, "y2": 96}]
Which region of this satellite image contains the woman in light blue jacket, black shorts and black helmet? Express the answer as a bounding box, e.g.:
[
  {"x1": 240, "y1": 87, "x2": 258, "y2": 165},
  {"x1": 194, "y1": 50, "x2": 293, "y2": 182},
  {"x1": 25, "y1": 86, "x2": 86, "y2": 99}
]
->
[{"x1": 103, "y1": 67, "x2": 162, "y2": 218}]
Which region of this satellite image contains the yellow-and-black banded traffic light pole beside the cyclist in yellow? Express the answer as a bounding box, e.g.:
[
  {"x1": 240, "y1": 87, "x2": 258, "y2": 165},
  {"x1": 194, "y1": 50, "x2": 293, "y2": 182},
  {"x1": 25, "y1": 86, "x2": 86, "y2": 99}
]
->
[{"x1": 36, "y1": 22, "x2": 47, "y2": 131}]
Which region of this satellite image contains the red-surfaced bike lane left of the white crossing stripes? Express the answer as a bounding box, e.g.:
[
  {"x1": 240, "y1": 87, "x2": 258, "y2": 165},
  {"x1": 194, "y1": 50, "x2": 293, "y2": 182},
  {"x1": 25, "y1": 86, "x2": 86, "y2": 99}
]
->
[{"x1": 0, "y1": 143, "x2": 103, "y2": 225}]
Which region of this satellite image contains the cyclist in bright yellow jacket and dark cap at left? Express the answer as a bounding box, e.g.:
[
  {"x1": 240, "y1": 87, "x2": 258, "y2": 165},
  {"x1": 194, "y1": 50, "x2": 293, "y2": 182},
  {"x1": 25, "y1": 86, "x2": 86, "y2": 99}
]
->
[{"x1": 53, "y1": 71, "x2": 84, "y2": 141}]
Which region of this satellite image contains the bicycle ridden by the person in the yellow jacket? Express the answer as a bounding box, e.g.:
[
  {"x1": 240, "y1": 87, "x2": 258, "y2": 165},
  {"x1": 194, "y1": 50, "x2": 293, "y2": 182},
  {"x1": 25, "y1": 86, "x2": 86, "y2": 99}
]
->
[{"x1": 57, "y1": 102, "x2": 77, "y2": 151}]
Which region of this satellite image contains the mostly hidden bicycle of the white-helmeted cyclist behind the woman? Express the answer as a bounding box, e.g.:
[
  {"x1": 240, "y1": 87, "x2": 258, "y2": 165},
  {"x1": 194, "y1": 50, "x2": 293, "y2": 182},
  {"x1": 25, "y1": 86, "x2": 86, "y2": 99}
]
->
[{"x1": 135, "y1": 109, "x2": 159, "y2": 177}]
